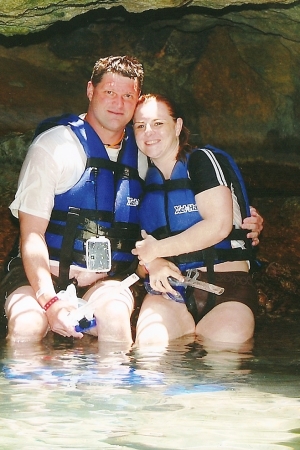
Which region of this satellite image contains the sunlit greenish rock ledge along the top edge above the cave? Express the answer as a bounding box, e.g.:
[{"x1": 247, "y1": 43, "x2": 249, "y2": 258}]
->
[{"x1": 0, "y1": 0, "x2": 299, "y2": 35}]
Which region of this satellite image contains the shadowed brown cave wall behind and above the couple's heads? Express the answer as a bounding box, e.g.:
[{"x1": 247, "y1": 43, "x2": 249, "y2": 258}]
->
[{"x1": 0, "y1": 2, "x2": 300, "y2": 164}]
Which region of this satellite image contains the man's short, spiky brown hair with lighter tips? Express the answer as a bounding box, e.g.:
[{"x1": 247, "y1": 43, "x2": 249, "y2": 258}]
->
[{"x1": 91, "y1": 55, "x2": 144, "y2": 91}]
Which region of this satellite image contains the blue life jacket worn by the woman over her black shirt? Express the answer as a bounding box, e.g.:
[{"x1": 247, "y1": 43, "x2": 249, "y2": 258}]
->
[{"x1": 140, "y1": 146, "x2": 253, "y2": 271}]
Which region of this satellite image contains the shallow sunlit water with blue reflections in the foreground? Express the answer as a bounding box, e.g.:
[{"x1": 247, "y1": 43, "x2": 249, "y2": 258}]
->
[{"x1": 0, "y1": 320, "x2": 300, "y2": 450}]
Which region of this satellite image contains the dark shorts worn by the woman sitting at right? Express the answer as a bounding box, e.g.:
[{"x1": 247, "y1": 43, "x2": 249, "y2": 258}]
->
[{"x1": 186, "y1": 272, "x2": 258, "y2": 323}]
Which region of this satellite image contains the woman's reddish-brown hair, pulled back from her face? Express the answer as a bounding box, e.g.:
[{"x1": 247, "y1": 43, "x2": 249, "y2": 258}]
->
[{"x1": 136, "y1": 94, "x2": 192, "y2": 161}]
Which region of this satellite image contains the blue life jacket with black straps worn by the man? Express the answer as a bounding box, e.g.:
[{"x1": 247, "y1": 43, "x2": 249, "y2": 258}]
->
[{"x1": 36, "y1": 115, "x2": 143, "y2": 285}]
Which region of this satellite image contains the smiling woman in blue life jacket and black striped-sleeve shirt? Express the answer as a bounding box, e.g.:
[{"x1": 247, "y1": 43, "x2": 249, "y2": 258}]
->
[{"x1": 132, "y1": 94, "x2": 257, "y2": 345}]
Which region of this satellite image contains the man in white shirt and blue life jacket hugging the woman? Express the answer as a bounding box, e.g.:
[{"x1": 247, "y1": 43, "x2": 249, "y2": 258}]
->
[{"x1": 3, "y1": 56, "x2": 262, "y2": 344}]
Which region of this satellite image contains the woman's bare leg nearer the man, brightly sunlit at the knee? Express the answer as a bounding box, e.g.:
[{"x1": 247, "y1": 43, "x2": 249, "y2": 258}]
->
[{"x1": 136, "y1": 294, "x2": 195, "y2": 347}]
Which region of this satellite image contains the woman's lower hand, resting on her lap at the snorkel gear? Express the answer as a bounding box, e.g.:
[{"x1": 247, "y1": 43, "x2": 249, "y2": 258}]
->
[{"x1": 147, "y1": 258, "x2": 184, "y2": 295}]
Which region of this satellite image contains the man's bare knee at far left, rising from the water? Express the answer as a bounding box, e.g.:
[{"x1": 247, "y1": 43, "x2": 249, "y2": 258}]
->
[{"x1": 5, "y1": 286, "x2": 49, "y2": 342}]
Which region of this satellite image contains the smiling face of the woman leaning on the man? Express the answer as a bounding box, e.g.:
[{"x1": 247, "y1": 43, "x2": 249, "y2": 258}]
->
[{"x1": 133, "y1": 99, "x2": 182, "y2": 160}]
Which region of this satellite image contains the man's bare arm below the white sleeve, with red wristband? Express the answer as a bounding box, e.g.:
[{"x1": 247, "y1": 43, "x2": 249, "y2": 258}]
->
[{"x1": 19, "y1": 211, "x2": 82, "y2": 337}]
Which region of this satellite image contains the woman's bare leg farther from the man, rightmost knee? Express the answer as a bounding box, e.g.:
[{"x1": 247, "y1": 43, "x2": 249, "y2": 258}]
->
[{"x1": 196, "y1": 301, "x2": 255, "y2": 344}]
